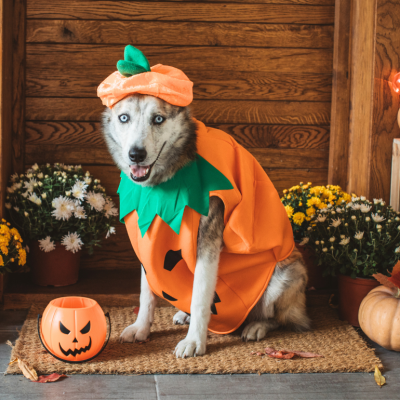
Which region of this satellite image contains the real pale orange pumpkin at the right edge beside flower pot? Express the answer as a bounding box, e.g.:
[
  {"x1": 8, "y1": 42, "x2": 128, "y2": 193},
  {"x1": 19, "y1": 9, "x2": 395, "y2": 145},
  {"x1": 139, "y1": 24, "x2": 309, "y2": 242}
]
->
[{"x1": 358, "y1": 286, "x2": 400, "y2": 351}]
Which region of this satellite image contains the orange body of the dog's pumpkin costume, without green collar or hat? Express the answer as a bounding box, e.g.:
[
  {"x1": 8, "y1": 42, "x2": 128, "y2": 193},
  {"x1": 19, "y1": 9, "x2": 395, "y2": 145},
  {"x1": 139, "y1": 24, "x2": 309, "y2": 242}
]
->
[{"x1": 121, "y1": 121, "x2": 294, "y2": 334}]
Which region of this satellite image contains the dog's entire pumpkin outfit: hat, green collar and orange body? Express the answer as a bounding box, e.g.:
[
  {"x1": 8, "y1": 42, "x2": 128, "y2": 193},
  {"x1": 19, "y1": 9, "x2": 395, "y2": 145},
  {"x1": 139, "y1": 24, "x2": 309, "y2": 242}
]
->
[{"x1": 98, "y1": 46, "x2": 294, "y2": 334}]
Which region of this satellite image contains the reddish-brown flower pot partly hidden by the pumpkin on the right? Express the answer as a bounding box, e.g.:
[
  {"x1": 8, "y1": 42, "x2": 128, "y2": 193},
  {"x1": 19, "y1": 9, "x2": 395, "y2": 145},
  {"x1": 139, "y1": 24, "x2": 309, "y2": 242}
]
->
[{"x1": 338, "y1": 275, "x2": 380, "y2": 327}]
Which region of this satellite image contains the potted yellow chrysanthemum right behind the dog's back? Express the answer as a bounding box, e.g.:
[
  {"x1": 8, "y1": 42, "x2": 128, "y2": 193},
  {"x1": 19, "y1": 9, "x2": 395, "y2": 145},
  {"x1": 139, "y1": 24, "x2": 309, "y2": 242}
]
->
[{"x1": 281, "y1": 182, "x2": 351, "y2": 289}]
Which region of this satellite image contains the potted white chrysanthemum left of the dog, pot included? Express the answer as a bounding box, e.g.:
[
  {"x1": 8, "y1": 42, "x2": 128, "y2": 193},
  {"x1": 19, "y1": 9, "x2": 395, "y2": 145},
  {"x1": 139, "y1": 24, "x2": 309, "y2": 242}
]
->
[{"x1": 6, "y1": 163, "x2": 118, "y2": 286}]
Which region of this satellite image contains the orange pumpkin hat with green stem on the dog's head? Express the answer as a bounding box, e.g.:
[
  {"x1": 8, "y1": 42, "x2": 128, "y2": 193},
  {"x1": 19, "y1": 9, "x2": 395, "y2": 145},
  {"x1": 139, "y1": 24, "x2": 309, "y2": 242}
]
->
[{"x1": 97, "y1": 45, "x2": 193, "y2": 108}]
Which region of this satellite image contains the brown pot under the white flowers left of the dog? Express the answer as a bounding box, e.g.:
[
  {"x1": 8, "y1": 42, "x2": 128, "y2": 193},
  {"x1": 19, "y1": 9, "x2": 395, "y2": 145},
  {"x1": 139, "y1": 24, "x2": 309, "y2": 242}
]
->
[{"x1": 30, "y1": 240, "x2": 81, "y2": 286}]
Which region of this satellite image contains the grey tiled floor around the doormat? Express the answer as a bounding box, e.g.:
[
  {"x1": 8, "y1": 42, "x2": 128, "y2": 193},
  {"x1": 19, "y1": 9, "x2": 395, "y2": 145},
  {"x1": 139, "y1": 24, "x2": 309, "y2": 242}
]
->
[{"x1": 0, "y1": 310, "x2": 400, "y2": 400}]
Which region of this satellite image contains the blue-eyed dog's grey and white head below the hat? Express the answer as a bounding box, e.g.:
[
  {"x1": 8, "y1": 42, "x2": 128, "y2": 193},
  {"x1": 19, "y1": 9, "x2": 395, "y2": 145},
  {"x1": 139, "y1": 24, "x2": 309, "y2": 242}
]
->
[{"x1": 102, "y1": 94, "x2": 196, "y2": 186}]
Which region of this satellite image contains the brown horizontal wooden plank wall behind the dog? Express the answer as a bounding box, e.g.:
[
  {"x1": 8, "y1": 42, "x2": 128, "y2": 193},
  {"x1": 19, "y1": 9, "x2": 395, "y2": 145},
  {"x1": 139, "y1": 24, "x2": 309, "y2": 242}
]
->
[{"x1": 24, "y1": 0, "x2": 334, "y2": 268}]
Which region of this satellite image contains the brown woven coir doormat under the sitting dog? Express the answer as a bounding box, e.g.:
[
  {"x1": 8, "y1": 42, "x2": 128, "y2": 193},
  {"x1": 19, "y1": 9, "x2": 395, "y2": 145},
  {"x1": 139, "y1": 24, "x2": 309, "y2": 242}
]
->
[{"x1": 7, "y1": 306, "x2": 382, "y2": 375}]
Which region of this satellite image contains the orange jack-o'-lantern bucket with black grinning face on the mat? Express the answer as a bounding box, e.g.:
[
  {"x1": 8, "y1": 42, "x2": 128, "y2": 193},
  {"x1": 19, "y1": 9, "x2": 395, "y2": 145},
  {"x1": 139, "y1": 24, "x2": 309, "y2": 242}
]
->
[{"x1": 38, "y1": 297, "x2": 111, "y2": 363}]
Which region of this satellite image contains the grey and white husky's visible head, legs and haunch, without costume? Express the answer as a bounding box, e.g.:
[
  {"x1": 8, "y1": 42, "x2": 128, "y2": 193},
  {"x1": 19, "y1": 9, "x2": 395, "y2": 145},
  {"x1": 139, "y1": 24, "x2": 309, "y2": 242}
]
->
[{"x1": 102, "y1": 94, "x2": 309, "y2": 358}]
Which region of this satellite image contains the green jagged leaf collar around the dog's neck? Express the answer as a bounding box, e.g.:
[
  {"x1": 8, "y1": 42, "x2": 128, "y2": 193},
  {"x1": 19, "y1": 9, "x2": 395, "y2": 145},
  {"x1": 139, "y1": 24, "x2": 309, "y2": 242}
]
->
[{"x1": 118, "y1": 155, "x2": 233, "y2": 237}]
